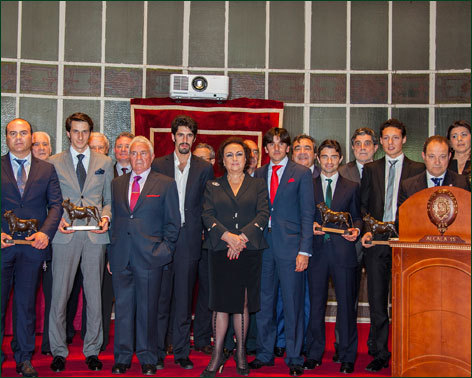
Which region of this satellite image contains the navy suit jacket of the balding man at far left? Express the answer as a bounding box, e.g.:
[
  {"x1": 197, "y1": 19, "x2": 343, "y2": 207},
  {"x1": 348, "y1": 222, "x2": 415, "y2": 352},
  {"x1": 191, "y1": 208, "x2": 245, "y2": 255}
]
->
[{"x1": 2, "y1": 154, "x2": 63, "y2": 260}]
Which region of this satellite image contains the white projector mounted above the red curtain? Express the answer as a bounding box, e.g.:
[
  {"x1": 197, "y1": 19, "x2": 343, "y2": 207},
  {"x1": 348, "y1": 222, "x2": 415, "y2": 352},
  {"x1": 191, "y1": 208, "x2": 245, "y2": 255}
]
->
[{"x1": 169, "y1": 74, "x2": 229, "y2": 101}]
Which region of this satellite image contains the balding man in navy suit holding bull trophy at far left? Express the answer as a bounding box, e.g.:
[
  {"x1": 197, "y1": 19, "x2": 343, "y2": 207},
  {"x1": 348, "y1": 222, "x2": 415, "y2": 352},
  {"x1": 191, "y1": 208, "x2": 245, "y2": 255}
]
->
[{"x1": 1, "y1": 118, "x2": 63, "y2": 377}]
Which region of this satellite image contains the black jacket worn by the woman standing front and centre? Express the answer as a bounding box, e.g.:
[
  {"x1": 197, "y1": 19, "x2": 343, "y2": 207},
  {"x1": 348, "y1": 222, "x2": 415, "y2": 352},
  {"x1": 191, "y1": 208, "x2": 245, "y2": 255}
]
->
[{"x1": 202, "y1": 174, "x2": 269, "y2": 251}]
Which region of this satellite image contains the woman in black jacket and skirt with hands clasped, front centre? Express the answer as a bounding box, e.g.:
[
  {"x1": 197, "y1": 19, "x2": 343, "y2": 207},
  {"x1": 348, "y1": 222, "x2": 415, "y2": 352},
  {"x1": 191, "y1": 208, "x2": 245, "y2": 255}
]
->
[{"x1": 201, "y1": 137, "x2": 269, "y2": 377}]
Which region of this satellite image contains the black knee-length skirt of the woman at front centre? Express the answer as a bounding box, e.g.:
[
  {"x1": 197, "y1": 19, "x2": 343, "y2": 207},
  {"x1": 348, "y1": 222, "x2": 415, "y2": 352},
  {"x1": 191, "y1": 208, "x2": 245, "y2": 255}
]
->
[{"x1": 208, "y1": 250, "x2": 262, "y2": 314}]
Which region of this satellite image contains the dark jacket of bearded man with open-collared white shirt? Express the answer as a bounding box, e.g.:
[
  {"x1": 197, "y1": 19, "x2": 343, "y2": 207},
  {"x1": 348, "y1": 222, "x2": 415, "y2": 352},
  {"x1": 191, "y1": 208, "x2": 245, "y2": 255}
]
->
[{"x1": 151, "y1": 153, "x2": 213, "y2": 260}]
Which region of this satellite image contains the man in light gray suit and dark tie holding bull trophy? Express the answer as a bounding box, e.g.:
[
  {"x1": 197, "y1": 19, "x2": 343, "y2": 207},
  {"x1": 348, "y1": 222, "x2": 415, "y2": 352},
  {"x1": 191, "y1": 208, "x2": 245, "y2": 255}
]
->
[{"x1": 49, "y1": 113, "x2": 113, "y2": 372}]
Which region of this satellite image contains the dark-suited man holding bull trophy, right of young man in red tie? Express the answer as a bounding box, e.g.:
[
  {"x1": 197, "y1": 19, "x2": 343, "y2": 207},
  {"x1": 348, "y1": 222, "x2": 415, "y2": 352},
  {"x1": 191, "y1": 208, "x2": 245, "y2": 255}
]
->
[{"x1": 303, "y1": 139, "x2": 362, "y2": 373}]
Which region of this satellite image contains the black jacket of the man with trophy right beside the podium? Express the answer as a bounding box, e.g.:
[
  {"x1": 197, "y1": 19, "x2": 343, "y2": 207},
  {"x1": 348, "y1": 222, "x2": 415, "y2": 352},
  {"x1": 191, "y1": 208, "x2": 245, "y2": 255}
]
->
[{"x1": 361, "y1": 156, "x2": 425, "y2": 232}]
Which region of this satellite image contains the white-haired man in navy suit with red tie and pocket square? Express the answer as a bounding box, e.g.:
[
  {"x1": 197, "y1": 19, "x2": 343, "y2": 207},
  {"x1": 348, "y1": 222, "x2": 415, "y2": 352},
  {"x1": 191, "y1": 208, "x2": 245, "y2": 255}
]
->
[{"x1": 109, "y1": 136, "x2": 180, "y2": 375}]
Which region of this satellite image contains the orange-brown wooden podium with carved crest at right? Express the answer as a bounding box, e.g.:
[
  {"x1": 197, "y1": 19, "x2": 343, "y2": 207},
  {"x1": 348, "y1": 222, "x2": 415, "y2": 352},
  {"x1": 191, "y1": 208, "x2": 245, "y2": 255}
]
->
[{"x1": 391, "y1": 187, "x2": 471, "y2": 377}]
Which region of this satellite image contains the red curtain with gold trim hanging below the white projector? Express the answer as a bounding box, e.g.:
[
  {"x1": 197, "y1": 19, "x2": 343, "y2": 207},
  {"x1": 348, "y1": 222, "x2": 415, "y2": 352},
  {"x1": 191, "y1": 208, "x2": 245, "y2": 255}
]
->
[{"x1": 131, "y1": 97, "x2": 283, "y2": 175}]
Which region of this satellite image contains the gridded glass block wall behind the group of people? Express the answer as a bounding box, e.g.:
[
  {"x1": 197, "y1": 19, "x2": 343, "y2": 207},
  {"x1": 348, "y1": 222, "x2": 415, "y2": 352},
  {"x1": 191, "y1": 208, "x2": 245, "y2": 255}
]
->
[{"x1": 1, "y1": 1, "x2": 471, "y2": 161}]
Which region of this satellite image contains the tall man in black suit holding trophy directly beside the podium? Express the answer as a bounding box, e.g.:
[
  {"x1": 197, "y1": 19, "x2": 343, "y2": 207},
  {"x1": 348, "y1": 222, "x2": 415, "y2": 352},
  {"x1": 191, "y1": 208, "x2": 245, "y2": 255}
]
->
[{"x1": 361, "y1": 118, "x2": 425, "y2": 371}]
